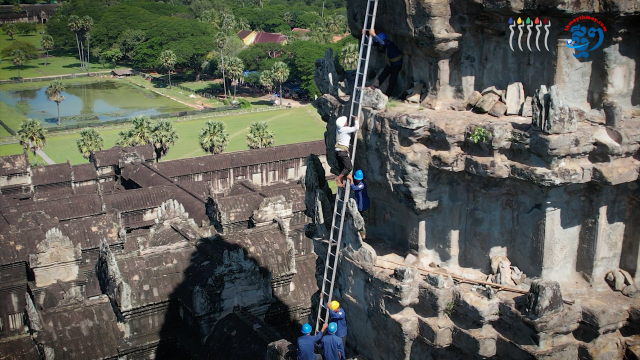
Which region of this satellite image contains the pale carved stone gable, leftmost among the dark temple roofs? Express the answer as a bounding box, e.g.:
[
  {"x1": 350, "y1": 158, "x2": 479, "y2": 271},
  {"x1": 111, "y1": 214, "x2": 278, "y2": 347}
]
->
[{"x1": 29, "y1": 228, "x2": 82, "y2": 287}]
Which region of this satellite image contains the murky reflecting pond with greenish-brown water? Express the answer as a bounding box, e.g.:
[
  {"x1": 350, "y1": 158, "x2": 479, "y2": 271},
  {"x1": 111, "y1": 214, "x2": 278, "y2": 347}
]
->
[{"x1": 0, "y1": 80, "x2": 191, "y2": 125}]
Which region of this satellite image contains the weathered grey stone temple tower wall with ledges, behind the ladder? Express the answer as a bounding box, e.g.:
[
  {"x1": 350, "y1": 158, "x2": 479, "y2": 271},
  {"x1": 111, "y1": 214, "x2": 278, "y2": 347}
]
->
[{"x1": 305, "y1": 0, "x2": 640, "y2": 359}]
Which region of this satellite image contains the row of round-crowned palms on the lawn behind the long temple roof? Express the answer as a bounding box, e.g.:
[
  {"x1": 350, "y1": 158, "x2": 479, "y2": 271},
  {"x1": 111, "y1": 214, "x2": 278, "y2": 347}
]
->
[{"x1": 17, "y1": 116, "x2": 275, "y2": 163}]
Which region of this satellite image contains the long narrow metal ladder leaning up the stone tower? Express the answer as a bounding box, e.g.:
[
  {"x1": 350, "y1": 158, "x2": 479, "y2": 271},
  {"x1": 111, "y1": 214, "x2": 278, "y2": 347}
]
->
[{"x1": 316, "y1": 0, "x2": 378, "y2": 333}]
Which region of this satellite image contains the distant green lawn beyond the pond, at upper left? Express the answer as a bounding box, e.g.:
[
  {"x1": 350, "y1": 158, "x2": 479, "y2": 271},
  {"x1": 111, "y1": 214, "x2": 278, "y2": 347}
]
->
[{"x1": 0, "y1": 26, "x2": 127, "y2": 80}]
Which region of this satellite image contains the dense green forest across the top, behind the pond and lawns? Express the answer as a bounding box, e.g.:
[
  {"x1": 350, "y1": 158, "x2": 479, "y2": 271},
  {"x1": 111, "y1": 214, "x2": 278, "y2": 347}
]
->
[{"x1": 46, "y1": 0, "x2": 355, "y2": 95}]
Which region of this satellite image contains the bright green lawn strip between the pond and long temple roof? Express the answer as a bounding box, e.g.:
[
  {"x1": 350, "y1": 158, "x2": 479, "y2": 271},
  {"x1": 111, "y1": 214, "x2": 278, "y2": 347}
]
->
[{"x1": 0, "y1": 106, "x2": 325, "y2": 164}]
